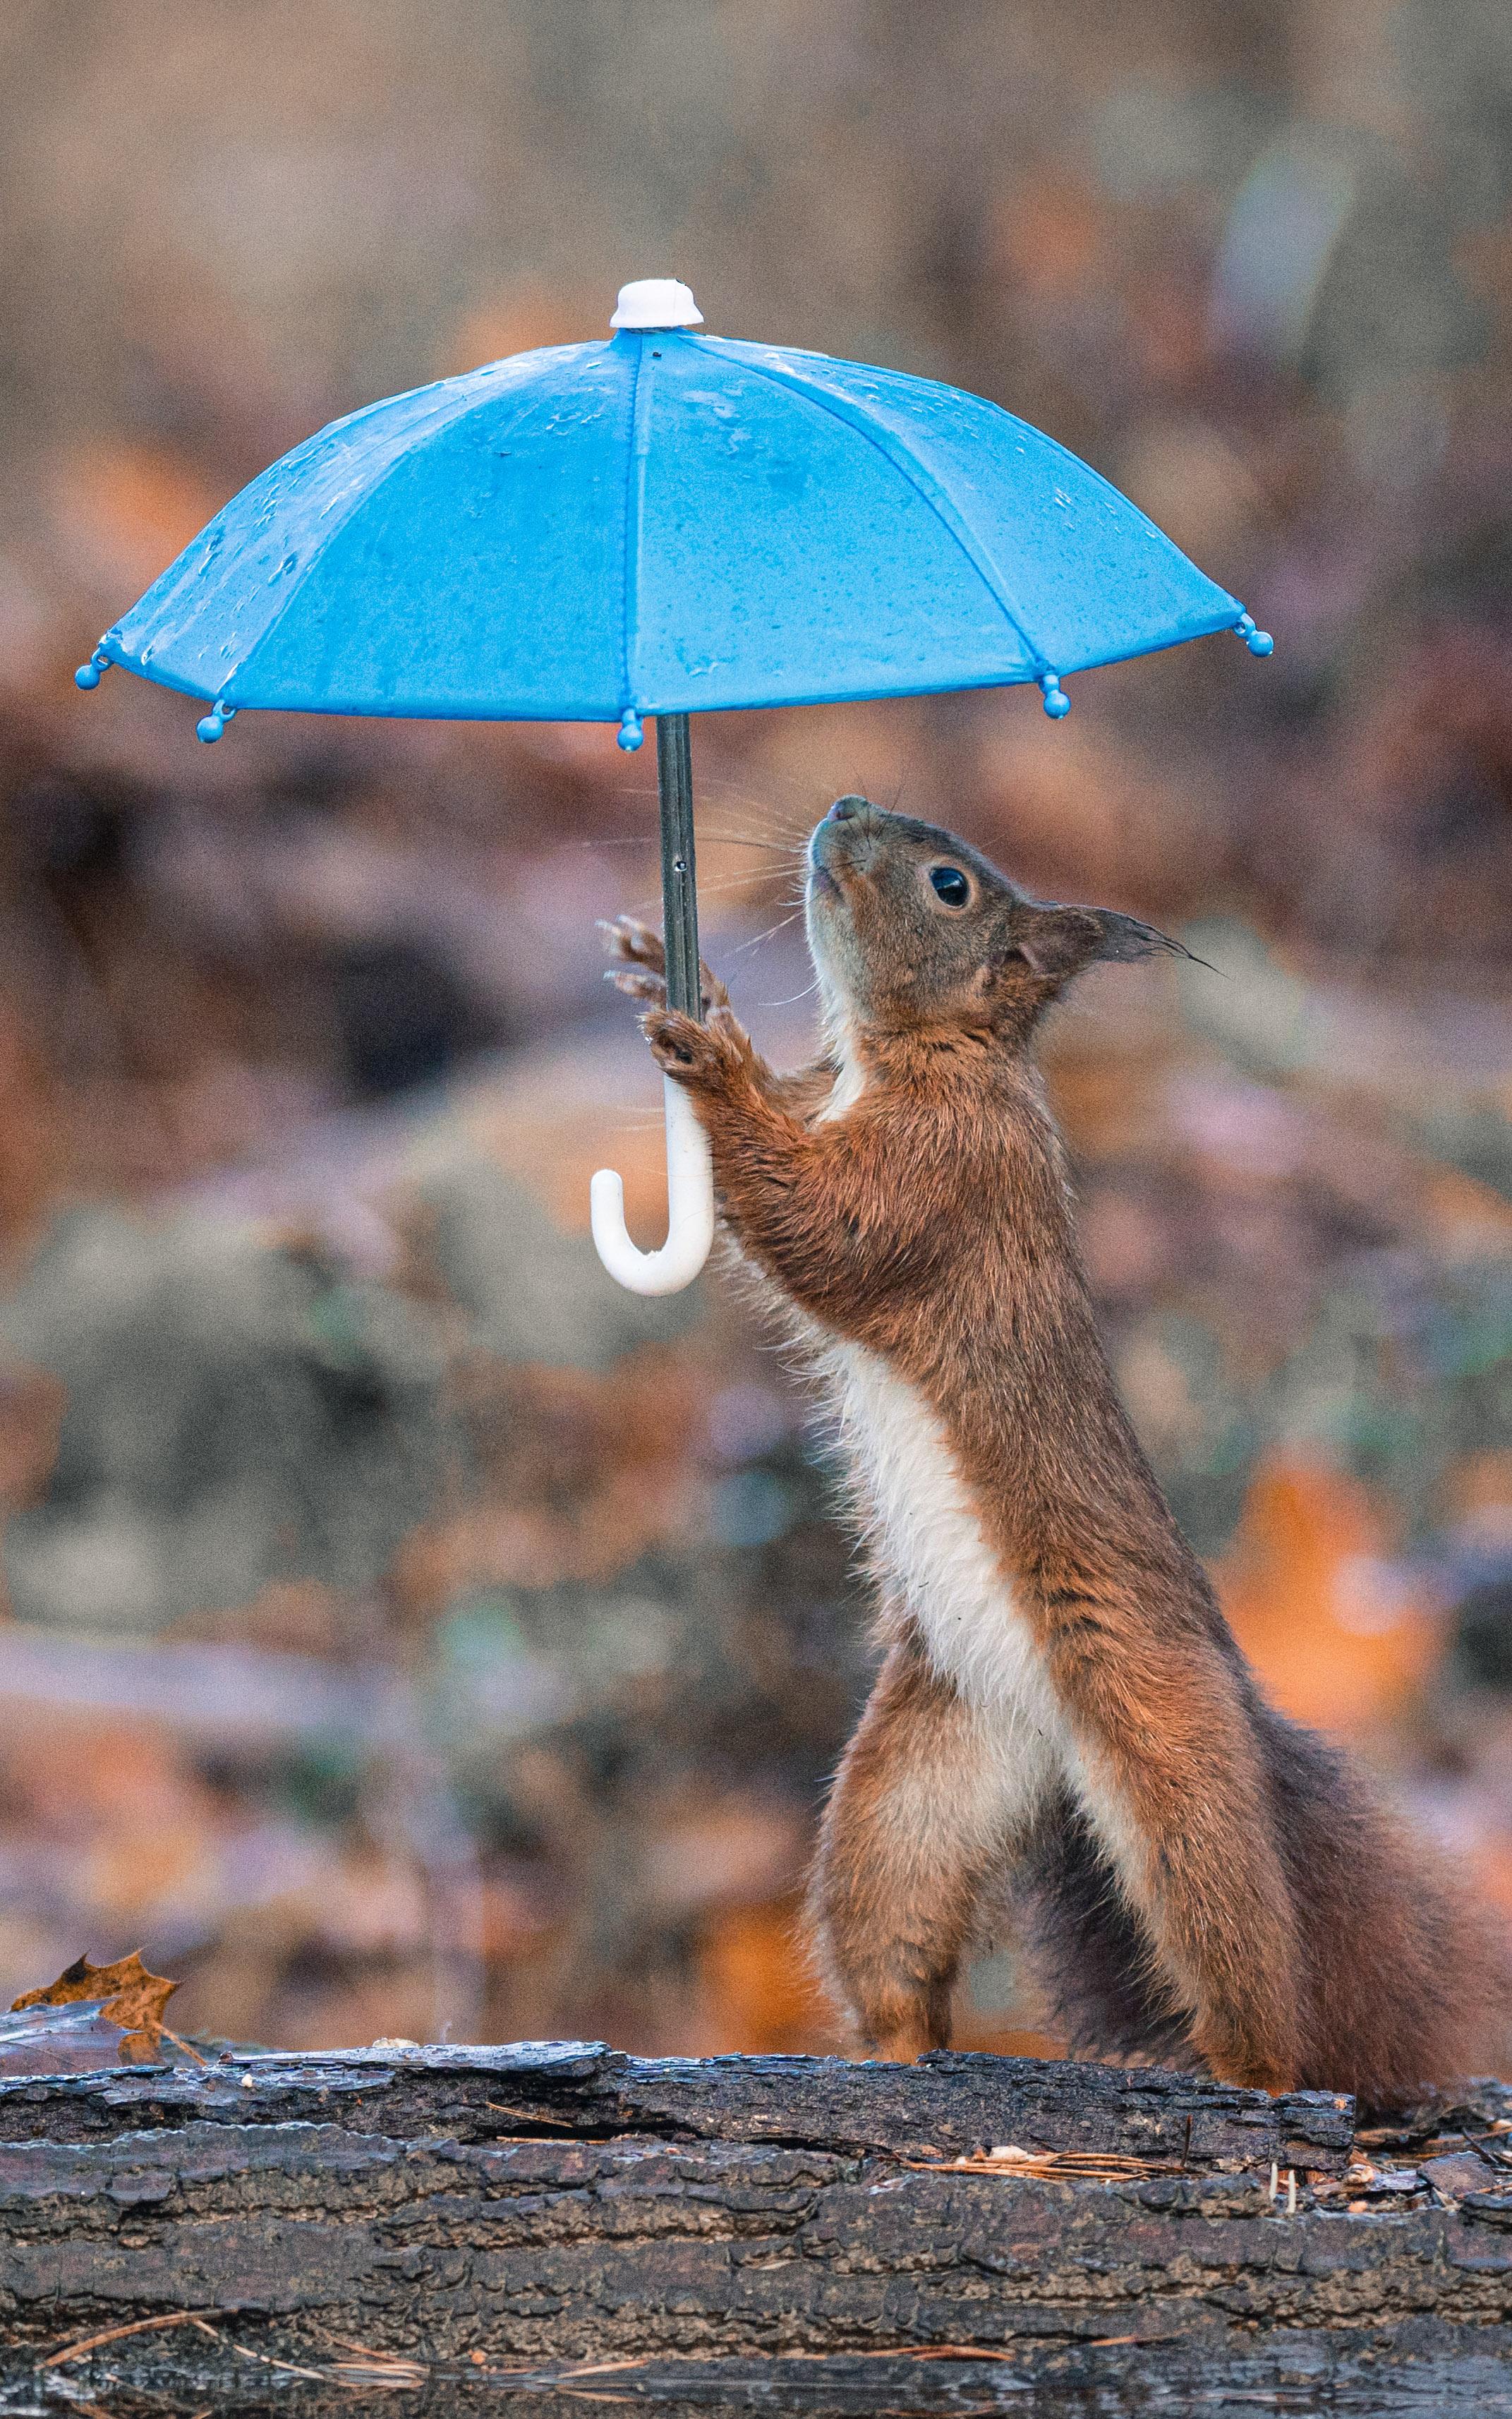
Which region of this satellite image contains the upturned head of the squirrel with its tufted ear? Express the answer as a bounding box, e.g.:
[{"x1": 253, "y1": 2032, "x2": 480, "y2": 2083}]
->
[{"x1": 806, "y1": 798, "x2": 1183, "y2": 1047}]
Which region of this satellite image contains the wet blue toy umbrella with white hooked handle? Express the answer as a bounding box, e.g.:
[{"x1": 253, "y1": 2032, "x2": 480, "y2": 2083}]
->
[{"x1": 75, "y1": 278, "x2": 1270, "y2": 1292}]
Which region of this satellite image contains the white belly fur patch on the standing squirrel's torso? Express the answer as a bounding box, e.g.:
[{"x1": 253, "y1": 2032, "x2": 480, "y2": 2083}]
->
[{"x1": 825, "y1": 1343, "x2": 1070, "y2": 1799}]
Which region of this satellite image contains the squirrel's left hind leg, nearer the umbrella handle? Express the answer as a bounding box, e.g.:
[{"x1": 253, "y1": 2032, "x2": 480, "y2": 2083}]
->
[{"x1": 808, "y1": 1638, "x2": 1036, "y2": 2061}]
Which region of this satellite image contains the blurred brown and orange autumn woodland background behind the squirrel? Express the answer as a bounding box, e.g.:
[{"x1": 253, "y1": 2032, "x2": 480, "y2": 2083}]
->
[{"x1": 0, "y1": 0, "x2": 1512, "y2": 2051}]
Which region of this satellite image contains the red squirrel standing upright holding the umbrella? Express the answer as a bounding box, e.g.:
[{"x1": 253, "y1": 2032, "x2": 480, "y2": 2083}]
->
[{"x1": 607, "y1": 798, "x2": 1510, "y2": 2107}]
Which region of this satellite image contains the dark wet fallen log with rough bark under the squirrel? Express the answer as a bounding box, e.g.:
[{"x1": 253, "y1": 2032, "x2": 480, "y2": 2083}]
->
[{"x1": 0, "y1": 2044, "x2": 1512, "y2": 2419}]
